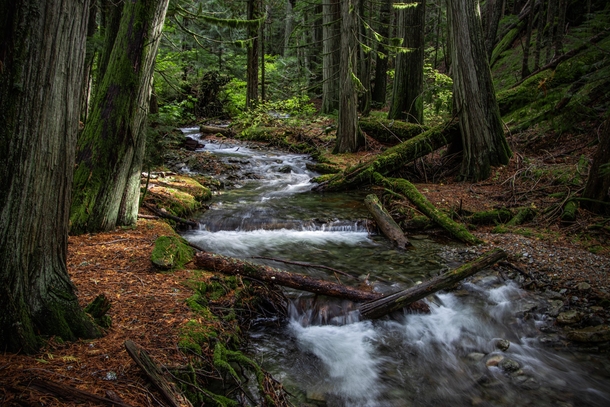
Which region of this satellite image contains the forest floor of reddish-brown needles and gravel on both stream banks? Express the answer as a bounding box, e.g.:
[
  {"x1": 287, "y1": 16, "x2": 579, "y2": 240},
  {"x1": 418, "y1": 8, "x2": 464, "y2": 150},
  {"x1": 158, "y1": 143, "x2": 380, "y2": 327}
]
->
[{"x1": 0, "y1": 119, "x2": 610, "y2": 406}]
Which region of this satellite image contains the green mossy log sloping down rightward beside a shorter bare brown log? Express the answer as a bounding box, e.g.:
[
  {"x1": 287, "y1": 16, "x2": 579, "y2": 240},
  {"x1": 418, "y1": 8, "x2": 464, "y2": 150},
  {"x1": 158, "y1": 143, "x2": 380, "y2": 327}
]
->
[{"x1": 377, "y1": 175, "x2": 483, "y2": 244}]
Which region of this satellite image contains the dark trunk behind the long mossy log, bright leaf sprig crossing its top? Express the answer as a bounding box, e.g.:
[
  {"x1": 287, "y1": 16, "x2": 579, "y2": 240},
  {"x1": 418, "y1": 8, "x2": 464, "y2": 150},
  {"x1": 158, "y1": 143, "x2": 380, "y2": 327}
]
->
[{"x1": 388, "y1": 0, "x2": 426, "y2": 124}]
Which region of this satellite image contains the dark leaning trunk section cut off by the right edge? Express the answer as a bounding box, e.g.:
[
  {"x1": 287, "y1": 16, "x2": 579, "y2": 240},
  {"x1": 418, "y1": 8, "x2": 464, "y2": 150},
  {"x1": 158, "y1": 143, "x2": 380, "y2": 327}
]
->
[{"x1": 581, "y1": 119, "x2": 610, "y2": 215}]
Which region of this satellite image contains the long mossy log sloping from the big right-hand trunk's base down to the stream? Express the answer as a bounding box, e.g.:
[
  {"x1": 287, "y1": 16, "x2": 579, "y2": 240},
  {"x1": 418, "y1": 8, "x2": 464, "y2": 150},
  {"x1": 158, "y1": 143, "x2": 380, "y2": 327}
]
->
[{"x1": 313, "y1": 123, "x2": 460, "y2": 191}]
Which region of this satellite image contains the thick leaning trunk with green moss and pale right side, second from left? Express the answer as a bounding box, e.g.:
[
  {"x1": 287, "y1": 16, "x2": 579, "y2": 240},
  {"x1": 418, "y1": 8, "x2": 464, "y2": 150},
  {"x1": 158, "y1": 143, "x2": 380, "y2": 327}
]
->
[{"x1": 70, "y1": 0, "x2": 169, "y2": 234}]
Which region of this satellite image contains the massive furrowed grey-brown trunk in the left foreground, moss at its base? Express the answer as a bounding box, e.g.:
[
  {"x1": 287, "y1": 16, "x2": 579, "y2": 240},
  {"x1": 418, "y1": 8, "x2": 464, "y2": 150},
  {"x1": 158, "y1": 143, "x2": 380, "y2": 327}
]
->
[{"x1": 0, "y1": 0, "x2": 100, "y2": 352}]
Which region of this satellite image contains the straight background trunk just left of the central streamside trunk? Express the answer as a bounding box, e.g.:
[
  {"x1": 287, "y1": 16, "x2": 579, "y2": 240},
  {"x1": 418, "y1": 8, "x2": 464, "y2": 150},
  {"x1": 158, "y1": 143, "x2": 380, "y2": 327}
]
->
[{"x1": 321, "y1": 0, "x2": 341, "y2": 113}]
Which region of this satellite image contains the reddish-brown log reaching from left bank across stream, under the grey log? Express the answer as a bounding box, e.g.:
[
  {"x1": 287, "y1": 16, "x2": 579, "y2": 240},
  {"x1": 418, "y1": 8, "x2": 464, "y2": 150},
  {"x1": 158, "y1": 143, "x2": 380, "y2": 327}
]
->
[{"x1": 195, "y1": 252, "x2": 428, "y2": 312}]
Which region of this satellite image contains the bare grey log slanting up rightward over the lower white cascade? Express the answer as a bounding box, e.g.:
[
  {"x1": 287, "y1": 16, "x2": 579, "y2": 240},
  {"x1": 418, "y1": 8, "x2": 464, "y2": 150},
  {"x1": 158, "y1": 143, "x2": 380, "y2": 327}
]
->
[{"x1": 359, "y1": 249, "x2": 506, "y2": 319}]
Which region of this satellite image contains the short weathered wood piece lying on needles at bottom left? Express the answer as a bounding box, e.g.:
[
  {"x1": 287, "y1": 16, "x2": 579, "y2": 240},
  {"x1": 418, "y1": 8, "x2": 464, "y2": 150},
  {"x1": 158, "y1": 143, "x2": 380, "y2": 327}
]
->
[{"x1": 125, "y1": 340, "x2": 193, "y2": 407}]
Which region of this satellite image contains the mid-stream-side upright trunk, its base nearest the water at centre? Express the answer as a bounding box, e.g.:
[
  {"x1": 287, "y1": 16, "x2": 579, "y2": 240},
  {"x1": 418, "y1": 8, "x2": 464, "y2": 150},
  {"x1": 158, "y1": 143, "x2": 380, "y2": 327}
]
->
[{"x1": 333, "y1": 0, "x2": 364, "y2": 153}]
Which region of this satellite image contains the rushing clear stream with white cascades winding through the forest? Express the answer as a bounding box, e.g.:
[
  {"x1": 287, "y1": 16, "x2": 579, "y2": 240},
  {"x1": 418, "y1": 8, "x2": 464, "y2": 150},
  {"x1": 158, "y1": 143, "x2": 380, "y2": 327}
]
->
[{"x1": 183, "y1": 128, "x2": 610, "y2": 406}]
